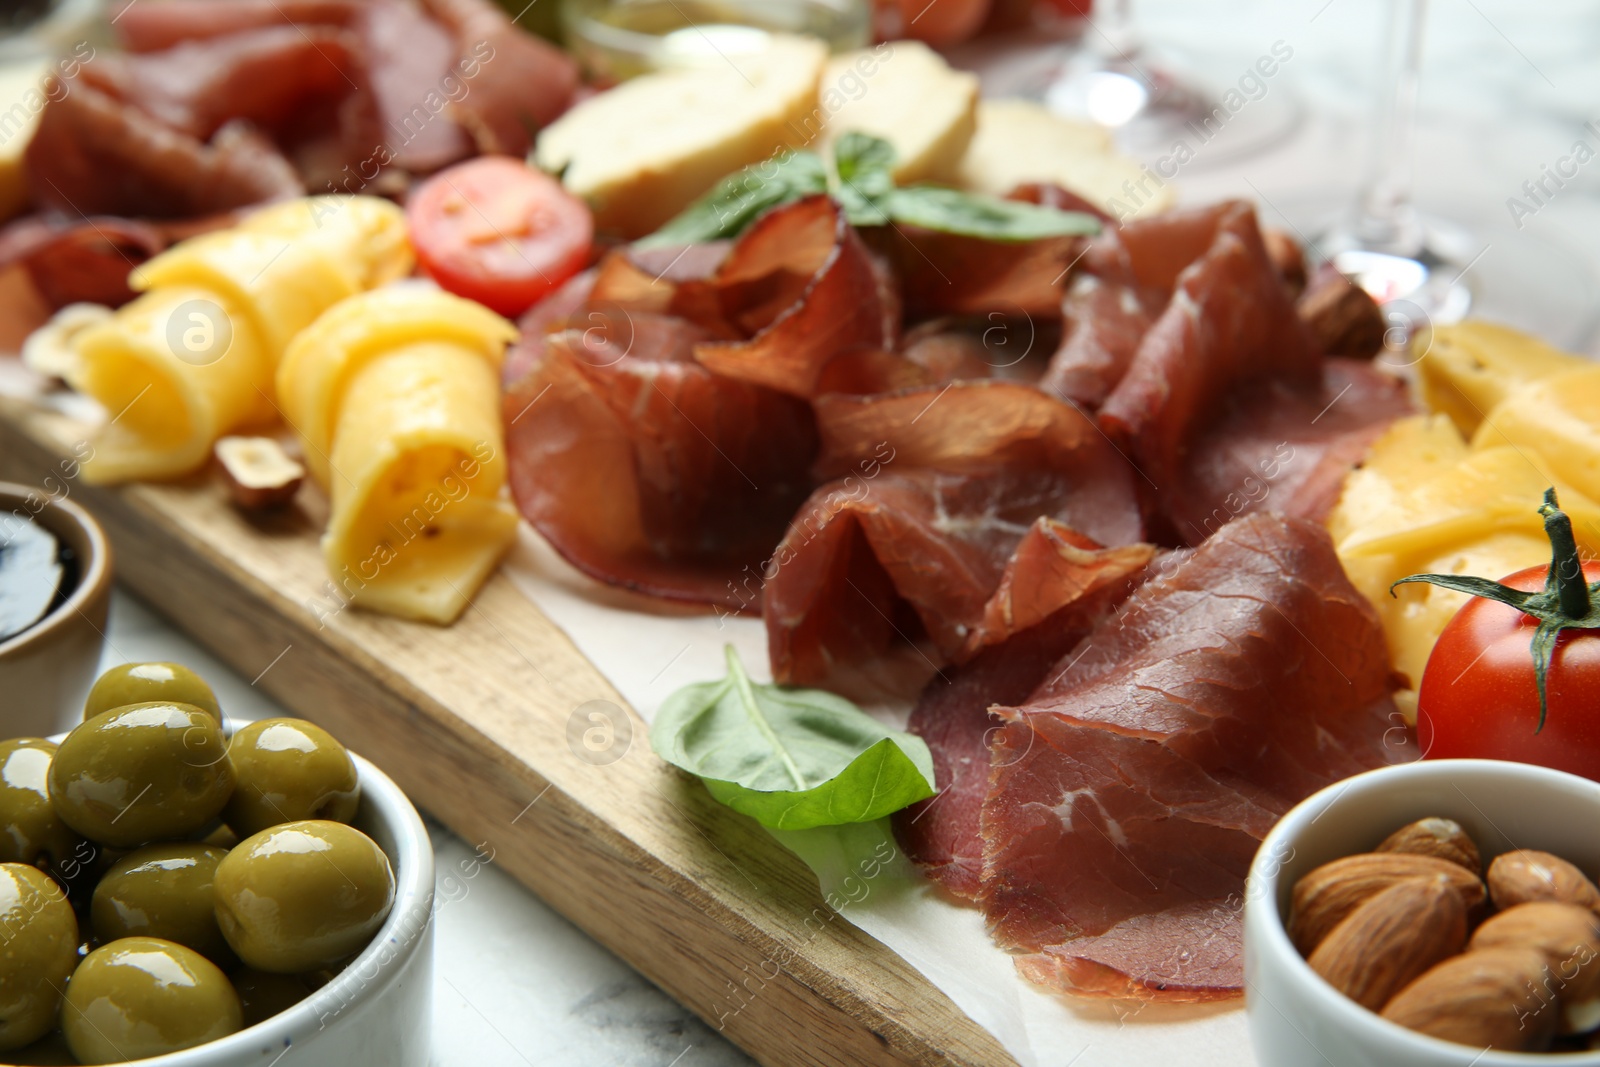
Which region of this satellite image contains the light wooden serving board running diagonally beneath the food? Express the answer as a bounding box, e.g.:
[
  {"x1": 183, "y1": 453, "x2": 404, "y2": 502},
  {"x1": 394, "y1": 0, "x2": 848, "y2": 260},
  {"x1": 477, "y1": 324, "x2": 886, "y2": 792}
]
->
[{"x1": 0, "y1": 397, "x2": 1014, "y2": 1067}]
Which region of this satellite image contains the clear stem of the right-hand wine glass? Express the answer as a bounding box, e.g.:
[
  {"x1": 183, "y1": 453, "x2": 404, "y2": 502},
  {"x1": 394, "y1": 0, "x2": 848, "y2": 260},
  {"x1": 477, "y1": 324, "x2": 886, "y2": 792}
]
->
[{"x1": 1355, "y1": 0, "x2": 1427, "y2": 256}]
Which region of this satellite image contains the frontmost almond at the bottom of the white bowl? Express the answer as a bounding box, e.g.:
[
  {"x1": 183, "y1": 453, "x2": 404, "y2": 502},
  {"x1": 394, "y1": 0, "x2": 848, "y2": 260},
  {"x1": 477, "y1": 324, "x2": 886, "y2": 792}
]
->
[{"x1": 1382, "y1": 947, "x2": 1557, "y2": 1051}]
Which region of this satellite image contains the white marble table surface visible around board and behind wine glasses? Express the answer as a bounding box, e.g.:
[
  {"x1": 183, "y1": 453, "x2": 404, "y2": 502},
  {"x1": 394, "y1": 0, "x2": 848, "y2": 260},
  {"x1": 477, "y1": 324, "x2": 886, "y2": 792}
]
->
[{"x1": 84, "y1": 0, "x2": 1600, "y2": 1067}]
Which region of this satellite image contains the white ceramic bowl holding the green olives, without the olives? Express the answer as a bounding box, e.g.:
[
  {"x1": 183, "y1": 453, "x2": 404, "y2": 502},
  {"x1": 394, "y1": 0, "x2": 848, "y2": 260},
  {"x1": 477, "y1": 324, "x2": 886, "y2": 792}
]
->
[{"x1": 50, "y1": 753, "x2": 434, "y2": 1067}]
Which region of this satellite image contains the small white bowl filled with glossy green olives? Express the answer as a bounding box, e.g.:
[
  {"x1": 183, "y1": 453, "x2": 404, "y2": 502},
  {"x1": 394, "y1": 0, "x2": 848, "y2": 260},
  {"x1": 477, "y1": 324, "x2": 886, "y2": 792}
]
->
[{"x1": 0, "y1": 664, "x2": 434, "y2": 1067}]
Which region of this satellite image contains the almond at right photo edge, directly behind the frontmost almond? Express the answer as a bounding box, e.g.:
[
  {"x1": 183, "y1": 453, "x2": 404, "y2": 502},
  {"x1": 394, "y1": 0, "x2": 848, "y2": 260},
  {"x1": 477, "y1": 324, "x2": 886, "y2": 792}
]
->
[{"x1": 1467, "y1": 901, "x2": 1600, "y2": 1033}]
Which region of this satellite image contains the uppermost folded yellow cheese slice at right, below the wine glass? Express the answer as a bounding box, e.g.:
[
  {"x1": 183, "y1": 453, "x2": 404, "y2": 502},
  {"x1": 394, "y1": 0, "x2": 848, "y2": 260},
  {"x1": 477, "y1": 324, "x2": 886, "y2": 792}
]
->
[{"x1": 1413, "y1": 320, "x2": 1589, "y2": 437}]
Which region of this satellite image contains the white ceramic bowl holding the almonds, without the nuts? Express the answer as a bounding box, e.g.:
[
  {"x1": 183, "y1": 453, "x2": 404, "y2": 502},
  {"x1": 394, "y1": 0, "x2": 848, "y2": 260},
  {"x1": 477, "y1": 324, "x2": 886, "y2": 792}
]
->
[{"x1": 1245, "y1": 760, "x2": 1600, "y2": 1067}]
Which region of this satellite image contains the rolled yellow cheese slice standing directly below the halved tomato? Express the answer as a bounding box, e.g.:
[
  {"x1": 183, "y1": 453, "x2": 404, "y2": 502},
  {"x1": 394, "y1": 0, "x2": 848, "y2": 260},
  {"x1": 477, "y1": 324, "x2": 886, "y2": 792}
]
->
[{"x1": 277, "y1": 292, "x2": 517, "y2": 624}]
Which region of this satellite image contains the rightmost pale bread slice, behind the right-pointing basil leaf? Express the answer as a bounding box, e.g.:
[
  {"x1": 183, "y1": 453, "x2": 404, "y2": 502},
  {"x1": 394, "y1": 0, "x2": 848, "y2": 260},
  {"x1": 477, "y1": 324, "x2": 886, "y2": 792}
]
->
[{"x1": 947, "y1": 97, "x2": 1176, "y2": 219}]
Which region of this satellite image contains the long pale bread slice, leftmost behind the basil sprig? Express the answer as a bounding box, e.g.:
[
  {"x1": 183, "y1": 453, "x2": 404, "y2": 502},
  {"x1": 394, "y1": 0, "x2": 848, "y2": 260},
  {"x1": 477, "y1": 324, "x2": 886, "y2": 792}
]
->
[{"x1": 534, "y1": 35, "x2": 827, "y2": 237}]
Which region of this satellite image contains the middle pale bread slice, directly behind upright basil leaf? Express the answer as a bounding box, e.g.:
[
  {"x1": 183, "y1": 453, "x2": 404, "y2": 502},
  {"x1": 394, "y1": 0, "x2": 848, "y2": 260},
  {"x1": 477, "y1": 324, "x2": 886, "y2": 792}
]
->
[{"x1": 818, "y1": 40, "x2": 978, "y2": 186}]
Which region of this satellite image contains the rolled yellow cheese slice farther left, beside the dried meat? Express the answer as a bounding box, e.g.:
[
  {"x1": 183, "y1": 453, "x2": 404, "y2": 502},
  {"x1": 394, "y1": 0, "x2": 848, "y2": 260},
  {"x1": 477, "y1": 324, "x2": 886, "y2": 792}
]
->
[{"x1": 70, "y1": 197, "x2": 413, "y2": 483}]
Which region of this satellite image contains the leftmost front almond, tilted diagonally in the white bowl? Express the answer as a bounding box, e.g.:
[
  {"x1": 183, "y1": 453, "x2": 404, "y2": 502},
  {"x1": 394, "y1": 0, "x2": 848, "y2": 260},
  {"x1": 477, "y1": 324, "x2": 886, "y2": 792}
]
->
[{"x1": 1307, "y1": 875, "x2": 1465, "y2": 1011}]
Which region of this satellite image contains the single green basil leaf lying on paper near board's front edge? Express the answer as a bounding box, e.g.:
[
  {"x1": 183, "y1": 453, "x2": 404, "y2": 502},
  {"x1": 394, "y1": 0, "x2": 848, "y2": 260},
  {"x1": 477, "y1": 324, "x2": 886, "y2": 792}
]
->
[{"x1": 650, "y1": 646, "x2": 934, "y2": 830}]
